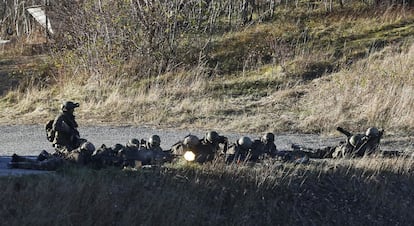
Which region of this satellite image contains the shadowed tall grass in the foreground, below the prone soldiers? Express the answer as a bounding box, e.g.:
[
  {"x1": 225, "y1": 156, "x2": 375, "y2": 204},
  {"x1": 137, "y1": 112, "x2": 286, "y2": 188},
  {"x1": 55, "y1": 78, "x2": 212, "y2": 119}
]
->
[{"x1": 0, "y1": 158, "x2": 414, "y2": 225}]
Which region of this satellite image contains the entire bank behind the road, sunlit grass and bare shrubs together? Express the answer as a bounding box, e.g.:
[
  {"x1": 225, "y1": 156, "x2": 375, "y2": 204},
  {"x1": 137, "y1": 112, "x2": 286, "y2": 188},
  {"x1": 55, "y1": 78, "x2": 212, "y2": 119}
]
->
[{"x1": 0, "y1": 0, "x2": 414, "y2": 135}]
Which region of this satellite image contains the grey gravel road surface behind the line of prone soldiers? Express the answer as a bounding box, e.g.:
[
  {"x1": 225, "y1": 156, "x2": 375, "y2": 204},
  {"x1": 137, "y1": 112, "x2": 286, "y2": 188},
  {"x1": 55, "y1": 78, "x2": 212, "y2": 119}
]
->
[{"x1": 0, "y1": 125, "x2": 414, "y2": 175}]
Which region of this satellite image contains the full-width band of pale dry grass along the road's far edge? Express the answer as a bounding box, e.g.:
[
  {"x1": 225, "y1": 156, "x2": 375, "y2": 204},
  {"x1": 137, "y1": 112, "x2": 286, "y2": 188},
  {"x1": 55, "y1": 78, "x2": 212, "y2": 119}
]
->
[{"x1": 2, "y1": 42, "x2": 414, "y2": 135}]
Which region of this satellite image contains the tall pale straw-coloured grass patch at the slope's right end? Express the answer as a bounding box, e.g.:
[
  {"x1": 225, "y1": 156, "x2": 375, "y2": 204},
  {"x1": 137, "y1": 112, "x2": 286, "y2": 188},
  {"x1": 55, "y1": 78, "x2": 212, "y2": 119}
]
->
[{"x1": 300, "y1": 46, "x2": 414, "y2": 134}]
